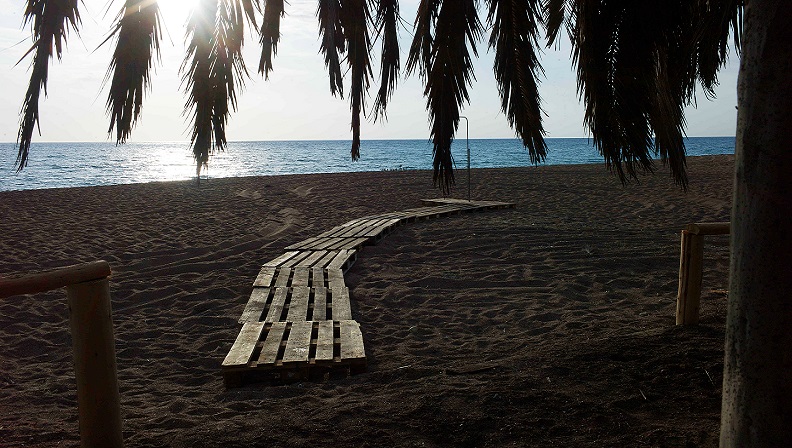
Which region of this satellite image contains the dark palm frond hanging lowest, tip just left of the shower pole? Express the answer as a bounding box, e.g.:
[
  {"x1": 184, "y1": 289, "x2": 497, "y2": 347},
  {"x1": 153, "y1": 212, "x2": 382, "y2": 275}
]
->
[{"x1": 408, "y1": 0, "x2": 482, "y2": 193}]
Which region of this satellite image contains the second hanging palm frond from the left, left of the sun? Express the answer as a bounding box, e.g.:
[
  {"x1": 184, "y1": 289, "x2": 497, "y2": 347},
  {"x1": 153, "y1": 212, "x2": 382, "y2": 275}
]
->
[{"x1": 105, "y1": 0, "x2": 161, "y2": 144}]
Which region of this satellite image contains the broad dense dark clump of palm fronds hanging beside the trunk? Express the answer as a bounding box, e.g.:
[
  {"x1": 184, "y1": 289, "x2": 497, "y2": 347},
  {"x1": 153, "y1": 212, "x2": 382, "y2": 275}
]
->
[{"x1": 570, "y1": 0, "x2": 743, "y2": 188}]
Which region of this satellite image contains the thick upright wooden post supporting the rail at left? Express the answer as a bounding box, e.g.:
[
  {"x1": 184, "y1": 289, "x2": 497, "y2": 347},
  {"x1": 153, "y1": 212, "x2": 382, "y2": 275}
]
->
[{"x1": 66, "y1": 277, "x2": 123, "y2": 448}]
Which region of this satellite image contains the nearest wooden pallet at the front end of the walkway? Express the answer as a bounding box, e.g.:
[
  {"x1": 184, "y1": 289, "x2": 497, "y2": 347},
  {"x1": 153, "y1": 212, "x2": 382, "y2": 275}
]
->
[{"x1": 222, "y1": 320, "x2": 366, "y2": 387}]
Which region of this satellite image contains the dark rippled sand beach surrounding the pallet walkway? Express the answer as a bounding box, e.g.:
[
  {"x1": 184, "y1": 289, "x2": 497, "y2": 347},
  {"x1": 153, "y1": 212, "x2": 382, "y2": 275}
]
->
[{"x1": 0, "y1": 156, "x2": 734, "y2": 447}]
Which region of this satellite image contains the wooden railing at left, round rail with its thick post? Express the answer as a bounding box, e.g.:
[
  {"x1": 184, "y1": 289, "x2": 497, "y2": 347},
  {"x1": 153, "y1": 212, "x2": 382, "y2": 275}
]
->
[{"x1": 0, "y1": 261, "x2": 123, "y2": 447}]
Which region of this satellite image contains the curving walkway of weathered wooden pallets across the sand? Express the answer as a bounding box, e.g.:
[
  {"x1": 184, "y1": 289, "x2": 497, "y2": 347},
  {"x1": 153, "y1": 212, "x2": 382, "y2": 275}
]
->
[{"x1": 222, "y1": 199, "x2": 514, "y2": 387}]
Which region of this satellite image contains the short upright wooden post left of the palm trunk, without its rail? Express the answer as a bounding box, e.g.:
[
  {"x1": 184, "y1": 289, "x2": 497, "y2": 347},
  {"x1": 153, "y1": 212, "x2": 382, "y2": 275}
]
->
[{"x1": 676, "y1": 230, "x2": 704, "y2": 325}]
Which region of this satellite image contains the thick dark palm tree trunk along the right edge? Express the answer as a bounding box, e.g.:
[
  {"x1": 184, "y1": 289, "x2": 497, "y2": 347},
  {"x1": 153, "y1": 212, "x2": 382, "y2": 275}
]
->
[{"x1": 720, "y1": 0, "x2": 792, "y2": 447}]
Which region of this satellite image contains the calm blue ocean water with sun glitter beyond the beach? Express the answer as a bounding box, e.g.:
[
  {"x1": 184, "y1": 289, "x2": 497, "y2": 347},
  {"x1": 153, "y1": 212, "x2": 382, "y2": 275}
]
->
[{"x1": 0, "y1": 137, "x2": 734, "y2": 191}]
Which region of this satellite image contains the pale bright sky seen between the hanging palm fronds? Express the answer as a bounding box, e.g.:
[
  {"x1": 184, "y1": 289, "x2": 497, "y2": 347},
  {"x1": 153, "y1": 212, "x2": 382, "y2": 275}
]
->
[{"x1": 0, "y1": 0, "x2": 739, "y2": 144}]
